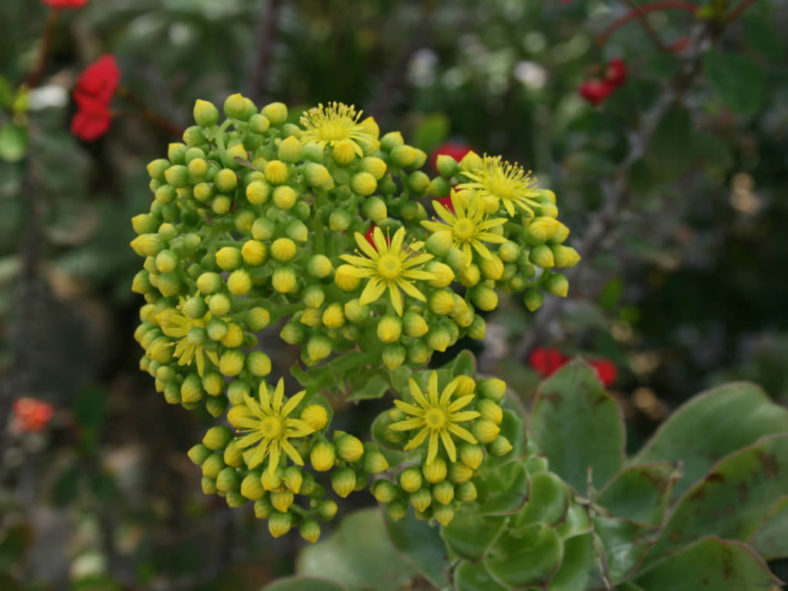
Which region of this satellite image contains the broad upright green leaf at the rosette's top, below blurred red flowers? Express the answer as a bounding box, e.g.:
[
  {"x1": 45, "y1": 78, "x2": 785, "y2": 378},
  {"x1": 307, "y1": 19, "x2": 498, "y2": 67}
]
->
[{"x1": 531, "y1": 361, "x2": 624, "y2": 492}]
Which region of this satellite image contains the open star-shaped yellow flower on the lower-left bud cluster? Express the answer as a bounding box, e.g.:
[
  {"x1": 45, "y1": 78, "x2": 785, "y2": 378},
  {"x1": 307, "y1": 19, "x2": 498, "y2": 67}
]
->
[{"x1": 227, "y1": 379, "x2": 315, "y2": 475}]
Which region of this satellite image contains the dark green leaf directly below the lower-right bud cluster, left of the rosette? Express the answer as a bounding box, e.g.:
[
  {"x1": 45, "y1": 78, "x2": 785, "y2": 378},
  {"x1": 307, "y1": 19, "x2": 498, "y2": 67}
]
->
[{"x1": 385, "y1": 511, "x2": 449, "y2": 587}]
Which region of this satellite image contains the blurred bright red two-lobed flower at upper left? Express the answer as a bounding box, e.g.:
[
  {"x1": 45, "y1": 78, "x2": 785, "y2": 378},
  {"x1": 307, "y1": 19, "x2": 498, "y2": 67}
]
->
[{"x1": 71, "y1": 55, "x2": 120, "y2": 142}]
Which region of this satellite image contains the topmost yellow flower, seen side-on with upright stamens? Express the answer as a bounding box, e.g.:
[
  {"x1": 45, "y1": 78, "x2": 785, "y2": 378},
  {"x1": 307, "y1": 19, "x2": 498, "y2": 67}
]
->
[{"x1": 301, "y1": 102, "x2": 377, "y2": 157}]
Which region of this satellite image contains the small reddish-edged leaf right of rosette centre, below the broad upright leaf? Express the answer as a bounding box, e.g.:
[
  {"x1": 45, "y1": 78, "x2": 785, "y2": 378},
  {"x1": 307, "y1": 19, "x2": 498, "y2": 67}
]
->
[{"x1": 598, "y1": 462, "x2": 681, "y2": 525}]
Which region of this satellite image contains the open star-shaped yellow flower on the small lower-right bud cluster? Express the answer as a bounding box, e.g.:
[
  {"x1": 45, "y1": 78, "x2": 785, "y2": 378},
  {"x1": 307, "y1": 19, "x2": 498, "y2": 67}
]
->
[{"x1": 389, "y1": 371, "x2": 479, "y2": 464}]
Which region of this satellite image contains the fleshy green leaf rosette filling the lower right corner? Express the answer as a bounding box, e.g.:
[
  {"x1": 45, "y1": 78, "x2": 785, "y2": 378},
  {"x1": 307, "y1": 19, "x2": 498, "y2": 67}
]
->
[{"x1": 292, "y1": 361, "x2": 788, "y2": 591}]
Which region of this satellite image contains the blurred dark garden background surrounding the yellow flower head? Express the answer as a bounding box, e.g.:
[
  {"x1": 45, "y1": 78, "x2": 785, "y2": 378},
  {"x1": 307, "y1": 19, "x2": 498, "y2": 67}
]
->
[{"x1": 0, "y1": 0, "x2": 788, "y2": 590}]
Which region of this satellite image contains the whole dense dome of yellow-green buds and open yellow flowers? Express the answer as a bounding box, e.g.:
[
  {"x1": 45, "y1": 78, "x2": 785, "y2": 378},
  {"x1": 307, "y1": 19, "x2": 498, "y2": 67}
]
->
[{"x1": 131, "y1": 94, "x2": 578, "y2": 541}]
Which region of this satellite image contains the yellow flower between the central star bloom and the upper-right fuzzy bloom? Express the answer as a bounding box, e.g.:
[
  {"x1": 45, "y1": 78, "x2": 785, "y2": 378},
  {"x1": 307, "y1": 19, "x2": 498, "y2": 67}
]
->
[{"x1": 421, "y1": 191, "x2": 506, "y2": 264}]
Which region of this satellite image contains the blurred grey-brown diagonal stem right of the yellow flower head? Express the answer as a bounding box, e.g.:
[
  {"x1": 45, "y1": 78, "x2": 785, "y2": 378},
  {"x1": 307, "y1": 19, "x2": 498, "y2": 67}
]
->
[{"x1": 513, "y1": 24, "x2": 719, "y2": 359}]
